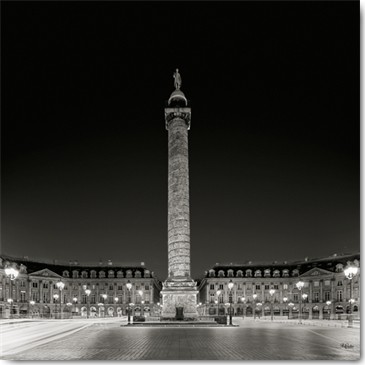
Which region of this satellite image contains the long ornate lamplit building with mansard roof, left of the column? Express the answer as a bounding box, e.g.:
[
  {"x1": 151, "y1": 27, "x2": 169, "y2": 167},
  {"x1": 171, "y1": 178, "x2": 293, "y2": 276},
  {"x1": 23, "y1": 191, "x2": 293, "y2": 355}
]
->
[{"x1": 0, "y1": 256, "x2": 161, "y2": 318}]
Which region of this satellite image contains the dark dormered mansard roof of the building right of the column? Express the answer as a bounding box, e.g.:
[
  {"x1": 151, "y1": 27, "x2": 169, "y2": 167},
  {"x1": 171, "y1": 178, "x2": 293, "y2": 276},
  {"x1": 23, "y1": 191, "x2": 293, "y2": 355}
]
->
[{"x1": 205, "y1": 253, "x2": 360, "y2": 277}]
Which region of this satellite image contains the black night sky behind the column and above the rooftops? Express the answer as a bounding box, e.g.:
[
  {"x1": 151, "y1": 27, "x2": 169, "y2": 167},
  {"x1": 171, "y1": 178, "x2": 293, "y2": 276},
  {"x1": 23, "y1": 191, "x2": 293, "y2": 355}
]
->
[{"x1": 1, "y1": 1, "x2": 360, "y2": 279}]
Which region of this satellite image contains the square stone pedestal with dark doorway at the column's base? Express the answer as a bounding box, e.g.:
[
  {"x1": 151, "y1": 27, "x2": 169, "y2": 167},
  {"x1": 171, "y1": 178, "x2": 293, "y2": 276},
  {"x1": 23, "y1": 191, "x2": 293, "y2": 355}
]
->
[{"x1": 161, "y1": 278, "x2": 199, "y2": 320}]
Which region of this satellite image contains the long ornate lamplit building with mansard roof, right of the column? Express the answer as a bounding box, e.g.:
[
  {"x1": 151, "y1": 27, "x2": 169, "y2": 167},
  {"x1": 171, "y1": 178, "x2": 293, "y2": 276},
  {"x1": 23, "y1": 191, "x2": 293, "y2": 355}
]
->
[{"x1": 199, "y1": 254, "x2": 360, "y2": 319}]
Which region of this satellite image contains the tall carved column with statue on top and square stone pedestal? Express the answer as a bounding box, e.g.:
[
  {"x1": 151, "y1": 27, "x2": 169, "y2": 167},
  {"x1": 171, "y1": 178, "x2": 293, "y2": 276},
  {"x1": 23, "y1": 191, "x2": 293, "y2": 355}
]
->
[{"x1": 161, "y1": 69, "x2": 198, "y2": 320}]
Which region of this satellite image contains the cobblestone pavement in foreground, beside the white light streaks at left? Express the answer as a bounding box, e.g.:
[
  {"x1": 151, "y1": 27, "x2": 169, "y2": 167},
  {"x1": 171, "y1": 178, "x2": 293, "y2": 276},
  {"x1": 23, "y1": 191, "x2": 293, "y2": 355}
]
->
[{"x1": 3, "y1": 321, "x2": 360, "y2": 360}]
